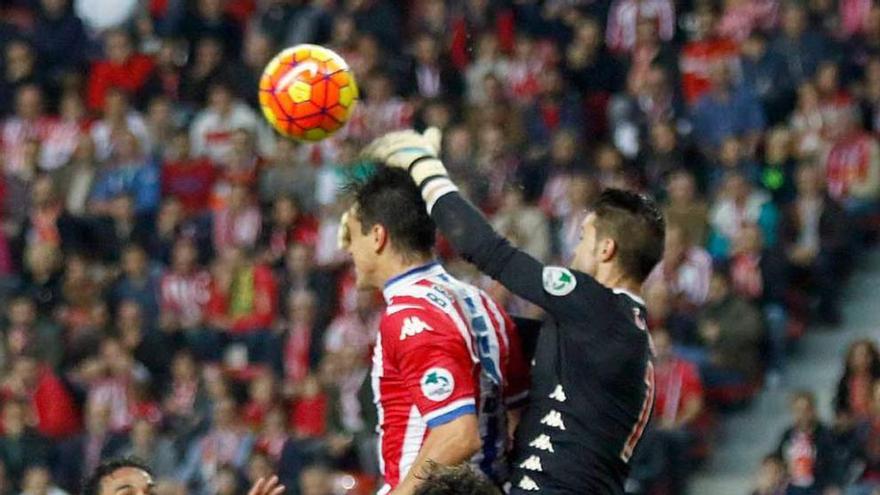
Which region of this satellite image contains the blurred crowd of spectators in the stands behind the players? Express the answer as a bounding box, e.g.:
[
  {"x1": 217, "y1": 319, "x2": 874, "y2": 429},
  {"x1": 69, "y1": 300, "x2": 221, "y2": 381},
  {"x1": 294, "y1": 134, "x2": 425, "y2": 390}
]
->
[{"x1": 0, "y1": 0, "x2": 880, "y2": 495}]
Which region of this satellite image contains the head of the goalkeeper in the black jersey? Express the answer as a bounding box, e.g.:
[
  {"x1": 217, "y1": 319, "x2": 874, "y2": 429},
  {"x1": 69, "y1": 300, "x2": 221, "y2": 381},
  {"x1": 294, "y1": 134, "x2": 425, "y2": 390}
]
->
[{"x1": 571, "y1": 189, "x2": 666, "y2": 284}]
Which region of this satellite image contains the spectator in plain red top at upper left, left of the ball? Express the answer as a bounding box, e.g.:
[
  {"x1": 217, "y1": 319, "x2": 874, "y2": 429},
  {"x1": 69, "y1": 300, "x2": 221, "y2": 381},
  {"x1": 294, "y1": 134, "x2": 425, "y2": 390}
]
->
[{"x1": 87, "y1": 30, "x2": 153, "y2": 112}]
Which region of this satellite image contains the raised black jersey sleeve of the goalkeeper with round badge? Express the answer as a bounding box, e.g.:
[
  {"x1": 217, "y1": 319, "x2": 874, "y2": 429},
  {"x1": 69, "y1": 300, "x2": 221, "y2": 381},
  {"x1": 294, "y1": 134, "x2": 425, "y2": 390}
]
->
[{"x1": 430, "y1": 191, "x2": 607, "y2": 321}]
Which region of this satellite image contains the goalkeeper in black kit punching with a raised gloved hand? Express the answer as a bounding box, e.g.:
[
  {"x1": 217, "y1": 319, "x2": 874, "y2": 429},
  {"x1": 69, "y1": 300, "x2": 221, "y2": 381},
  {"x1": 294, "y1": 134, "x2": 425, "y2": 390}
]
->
[{"x1": 364, "y1": 129, "x2": 665, "y2": 495}]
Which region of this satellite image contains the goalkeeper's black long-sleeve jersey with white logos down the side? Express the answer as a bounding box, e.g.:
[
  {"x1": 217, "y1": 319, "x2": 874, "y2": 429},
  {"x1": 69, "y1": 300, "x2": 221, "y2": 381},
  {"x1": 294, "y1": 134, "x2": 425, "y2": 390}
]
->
[{"x1": 431, "y1": 192, "x2": 654, "y2": 495}]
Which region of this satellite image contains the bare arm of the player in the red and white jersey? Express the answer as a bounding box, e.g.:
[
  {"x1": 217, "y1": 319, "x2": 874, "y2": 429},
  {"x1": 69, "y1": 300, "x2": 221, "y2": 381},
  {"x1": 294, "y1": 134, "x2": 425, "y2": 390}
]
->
[{"x1": 391, "y1": 414, "x2": 480, "y2": 495}]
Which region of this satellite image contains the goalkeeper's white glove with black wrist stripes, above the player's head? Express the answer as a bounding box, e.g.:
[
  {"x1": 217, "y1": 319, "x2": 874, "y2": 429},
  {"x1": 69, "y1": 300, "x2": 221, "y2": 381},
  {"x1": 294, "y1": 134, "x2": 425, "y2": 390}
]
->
[{"x1": 363, "y1": 127, "x2": 458, "y2": 213}]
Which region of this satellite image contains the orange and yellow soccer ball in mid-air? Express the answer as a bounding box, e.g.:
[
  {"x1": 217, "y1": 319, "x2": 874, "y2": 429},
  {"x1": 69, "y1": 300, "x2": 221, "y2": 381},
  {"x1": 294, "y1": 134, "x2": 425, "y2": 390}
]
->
[{"x1": 260, "y1": 44, "x2": 358, "y2": 141}]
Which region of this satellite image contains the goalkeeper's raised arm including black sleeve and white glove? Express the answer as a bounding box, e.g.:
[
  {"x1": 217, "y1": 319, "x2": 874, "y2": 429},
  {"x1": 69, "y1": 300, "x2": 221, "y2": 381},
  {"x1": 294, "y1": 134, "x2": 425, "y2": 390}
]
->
[{"x1": 366, "y1": 129, "x2": 600, "y2": 319}]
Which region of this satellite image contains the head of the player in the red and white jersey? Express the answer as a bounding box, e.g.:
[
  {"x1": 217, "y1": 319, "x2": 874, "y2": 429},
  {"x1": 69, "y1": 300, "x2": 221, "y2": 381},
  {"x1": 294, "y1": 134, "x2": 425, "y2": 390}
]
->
[{"x1": 345, "y1": 166, "x2": 435, "y2": 288}]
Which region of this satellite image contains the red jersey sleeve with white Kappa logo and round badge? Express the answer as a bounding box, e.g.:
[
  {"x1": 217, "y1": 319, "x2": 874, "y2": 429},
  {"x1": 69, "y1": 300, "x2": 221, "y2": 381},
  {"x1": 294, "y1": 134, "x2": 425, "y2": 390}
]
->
[{"x1": 382, "y1": 306, "x2": 478, "y2": 428}]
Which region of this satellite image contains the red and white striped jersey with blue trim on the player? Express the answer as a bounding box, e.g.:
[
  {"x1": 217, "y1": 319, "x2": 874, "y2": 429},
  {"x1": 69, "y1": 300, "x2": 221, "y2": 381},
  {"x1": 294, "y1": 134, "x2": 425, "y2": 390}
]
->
[{"x1": 372, "y1": 262, "x2": 528, "y2": 494}]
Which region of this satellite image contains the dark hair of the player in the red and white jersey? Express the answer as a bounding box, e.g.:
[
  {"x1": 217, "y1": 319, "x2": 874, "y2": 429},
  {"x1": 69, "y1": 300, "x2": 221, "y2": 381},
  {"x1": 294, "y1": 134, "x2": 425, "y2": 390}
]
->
[{"x1": 349, "y1": 165, "x2": 436, "y2": 257}]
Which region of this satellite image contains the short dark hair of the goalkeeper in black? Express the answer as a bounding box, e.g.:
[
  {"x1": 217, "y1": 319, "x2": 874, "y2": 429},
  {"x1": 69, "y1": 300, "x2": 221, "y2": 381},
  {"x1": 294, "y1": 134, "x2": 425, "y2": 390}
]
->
[{"x1": 593, "y1": 189, "x2": 666, "y2": 283}]
